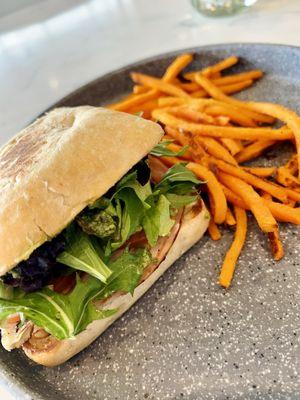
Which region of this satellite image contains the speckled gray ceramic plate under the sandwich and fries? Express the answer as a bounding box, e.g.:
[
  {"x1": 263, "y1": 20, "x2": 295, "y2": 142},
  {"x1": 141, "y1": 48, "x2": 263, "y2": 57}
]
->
[{"x1": 0, "y1": 44, "x2": 300, "y2": 400}]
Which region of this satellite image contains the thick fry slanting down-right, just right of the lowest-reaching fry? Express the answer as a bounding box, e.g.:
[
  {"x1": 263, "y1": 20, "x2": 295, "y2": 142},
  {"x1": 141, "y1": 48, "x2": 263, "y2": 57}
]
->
[{"x1": 218, "y1": 172, "x2": 277, "y2": 232}]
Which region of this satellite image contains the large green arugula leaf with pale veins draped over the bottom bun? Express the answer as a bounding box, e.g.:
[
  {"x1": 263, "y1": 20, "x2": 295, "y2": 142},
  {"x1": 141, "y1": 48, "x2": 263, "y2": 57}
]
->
[{"x1": 0, "y1": 249, "x2": 152, "y2": 340}]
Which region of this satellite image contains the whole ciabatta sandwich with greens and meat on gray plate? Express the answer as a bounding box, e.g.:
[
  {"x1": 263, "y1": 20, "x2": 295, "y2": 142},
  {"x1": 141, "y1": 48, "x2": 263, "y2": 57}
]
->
[{"x1": 0, "y1": 106, "x2": 209, "y2": 366}]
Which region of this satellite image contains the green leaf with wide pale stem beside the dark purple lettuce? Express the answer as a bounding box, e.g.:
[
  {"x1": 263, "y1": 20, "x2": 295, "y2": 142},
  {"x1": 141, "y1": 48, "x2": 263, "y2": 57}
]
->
[{"x1": 57, "y1": 225, "x2": 112, "y2": 283}]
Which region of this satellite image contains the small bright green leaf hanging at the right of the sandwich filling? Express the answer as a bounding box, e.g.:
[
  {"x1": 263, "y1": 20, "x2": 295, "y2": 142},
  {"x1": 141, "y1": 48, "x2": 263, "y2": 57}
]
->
[{"x1": 142, "y1": 195, "x2": 174, "y2": 246}]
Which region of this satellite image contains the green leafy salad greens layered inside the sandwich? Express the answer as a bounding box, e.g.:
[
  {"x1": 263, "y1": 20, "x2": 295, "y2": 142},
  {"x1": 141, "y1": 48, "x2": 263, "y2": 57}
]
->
[{"x1": 0, "y1": 162, "x2": 200, "y2": 339}]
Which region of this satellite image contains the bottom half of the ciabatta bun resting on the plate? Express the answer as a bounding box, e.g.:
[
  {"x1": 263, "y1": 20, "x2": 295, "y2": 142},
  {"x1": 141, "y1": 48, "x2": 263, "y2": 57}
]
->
[{"x1": 23, "y1": 201, "x2": 209, "y2": 367}]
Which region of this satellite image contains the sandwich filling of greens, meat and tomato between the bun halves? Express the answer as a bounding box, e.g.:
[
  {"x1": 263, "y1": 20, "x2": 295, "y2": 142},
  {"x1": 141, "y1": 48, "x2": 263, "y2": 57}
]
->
[{"x1": 0, "y1": 144, "x2": 204, "y2": 351}]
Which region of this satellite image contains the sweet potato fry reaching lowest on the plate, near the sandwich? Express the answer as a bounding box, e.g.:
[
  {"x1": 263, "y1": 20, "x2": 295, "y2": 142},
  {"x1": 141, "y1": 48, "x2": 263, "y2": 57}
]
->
[{"x1": 219, "y1": 206, "x2": 247, "y2": 288}]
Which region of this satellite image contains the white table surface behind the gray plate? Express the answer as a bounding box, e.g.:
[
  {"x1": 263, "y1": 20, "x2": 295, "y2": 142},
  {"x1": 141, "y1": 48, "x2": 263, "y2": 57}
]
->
[{"x1": 0, "y1": 0, "x2": 300, "y2": 400}]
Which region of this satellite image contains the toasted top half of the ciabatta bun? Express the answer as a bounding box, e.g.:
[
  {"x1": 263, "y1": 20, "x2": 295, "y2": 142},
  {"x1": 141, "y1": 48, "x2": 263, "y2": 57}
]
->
[{"x1": 0, "y1": 106, "x2": 163, "y2": 276}]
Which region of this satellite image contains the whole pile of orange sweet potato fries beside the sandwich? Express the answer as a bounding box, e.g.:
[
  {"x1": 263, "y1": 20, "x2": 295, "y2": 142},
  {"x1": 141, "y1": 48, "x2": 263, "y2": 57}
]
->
[{"x1": 109, "y1": 54, "x2": 300, "y2": 288}]
